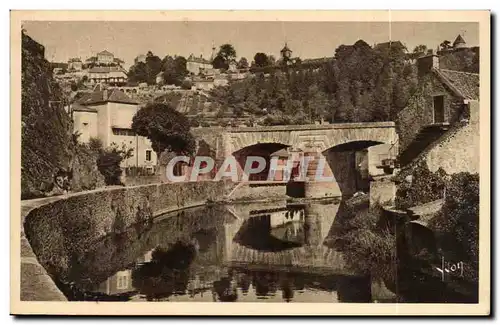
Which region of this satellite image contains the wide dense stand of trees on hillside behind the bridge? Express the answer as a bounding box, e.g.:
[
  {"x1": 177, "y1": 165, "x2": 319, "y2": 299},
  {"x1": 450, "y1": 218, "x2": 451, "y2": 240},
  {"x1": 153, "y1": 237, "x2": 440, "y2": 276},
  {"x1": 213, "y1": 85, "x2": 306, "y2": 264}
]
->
[{"x1": 213, "y1": 41, "x2": 417, "y2": 124}]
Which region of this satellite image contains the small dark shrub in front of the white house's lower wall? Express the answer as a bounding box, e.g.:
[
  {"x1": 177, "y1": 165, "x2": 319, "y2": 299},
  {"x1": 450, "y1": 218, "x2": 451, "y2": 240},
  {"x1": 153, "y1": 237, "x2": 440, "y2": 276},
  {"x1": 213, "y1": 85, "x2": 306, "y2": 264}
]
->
[{"x1": 97, "y1": 145, "x2": 133, "y2": 185}]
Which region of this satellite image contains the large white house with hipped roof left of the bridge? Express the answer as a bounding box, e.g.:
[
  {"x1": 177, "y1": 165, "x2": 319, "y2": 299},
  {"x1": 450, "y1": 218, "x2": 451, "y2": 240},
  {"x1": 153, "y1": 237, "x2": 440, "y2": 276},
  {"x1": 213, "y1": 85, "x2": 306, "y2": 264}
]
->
[{"x1": 72, "y1": 85, "x2": 157, "y2": 167}]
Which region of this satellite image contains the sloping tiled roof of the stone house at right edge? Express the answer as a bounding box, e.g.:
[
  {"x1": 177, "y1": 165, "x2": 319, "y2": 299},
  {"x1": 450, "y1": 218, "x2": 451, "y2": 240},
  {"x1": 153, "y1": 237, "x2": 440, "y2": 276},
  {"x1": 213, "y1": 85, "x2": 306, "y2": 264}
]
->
[{"x1": 435, "y1": 69, "x2": 479, "y2": 100}]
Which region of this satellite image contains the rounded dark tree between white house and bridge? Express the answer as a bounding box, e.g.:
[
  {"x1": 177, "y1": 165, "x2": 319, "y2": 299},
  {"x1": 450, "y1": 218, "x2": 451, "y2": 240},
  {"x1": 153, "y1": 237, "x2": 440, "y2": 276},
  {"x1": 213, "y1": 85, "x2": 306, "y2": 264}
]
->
[{"x1": 132, "y1": 103, "x2": 195, "y2": 155}]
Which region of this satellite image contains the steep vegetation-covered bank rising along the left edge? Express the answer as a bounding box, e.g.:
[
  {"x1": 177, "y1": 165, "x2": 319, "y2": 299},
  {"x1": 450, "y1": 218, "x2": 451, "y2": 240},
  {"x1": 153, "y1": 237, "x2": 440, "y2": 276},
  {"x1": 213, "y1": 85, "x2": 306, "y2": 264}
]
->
[{"x1": 21, "y1": 34, "x2": 104, "y2": 199}]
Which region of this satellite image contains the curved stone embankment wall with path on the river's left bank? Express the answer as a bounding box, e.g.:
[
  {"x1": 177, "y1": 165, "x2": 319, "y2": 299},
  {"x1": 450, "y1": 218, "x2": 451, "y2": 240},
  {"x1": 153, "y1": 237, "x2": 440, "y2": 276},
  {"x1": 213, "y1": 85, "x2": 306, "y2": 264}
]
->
[{"x1": 21, "y1": 181, "x2": 226, "y2": 300}]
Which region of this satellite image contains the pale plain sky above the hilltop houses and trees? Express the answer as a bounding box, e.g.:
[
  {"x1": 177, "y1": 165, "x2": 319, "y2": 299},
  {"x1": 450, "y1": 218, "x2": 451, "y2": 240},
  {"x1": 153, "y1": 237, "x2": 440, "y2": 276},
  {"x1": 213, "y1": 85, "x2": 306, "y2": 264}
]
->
[{"x1": 23, "y1": 21, "x2": 479, "y2": 68}]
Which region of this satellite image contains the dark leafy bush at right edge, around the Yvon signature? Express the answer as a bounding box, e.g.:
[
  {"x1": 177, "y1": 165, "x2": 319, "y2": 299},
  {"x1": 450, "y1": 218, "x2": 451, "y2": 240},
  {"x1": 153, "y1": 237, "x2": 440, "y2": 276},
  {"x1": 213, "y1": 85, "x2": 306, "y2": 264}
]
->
[{"x1": 430, "y1": 173, "x2": 479, "y2": 282}]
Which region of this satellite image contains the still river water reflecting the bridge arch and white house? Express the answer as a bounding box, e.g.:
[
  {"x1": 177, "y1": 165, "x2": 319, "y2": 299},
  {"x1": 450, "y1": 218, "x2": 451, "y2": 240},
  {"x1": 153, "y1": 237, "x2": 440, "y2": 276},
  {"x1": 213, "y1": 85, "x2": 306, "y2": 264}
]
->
[{"x1": 58, "y1": 202, "x2": 393, "y2": 302}]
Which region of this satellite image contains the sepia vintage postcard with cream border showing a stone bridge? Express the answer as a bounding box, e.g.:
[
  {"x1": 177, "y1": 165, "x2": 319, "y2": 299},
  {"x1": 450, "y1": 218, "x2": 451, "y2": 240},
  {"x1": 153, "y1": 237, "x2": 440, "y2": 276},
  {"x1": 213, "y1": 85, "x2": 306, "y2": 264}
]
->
[{"x1": 11, "y1": 10, "x2": 491, "y2": 316}]
